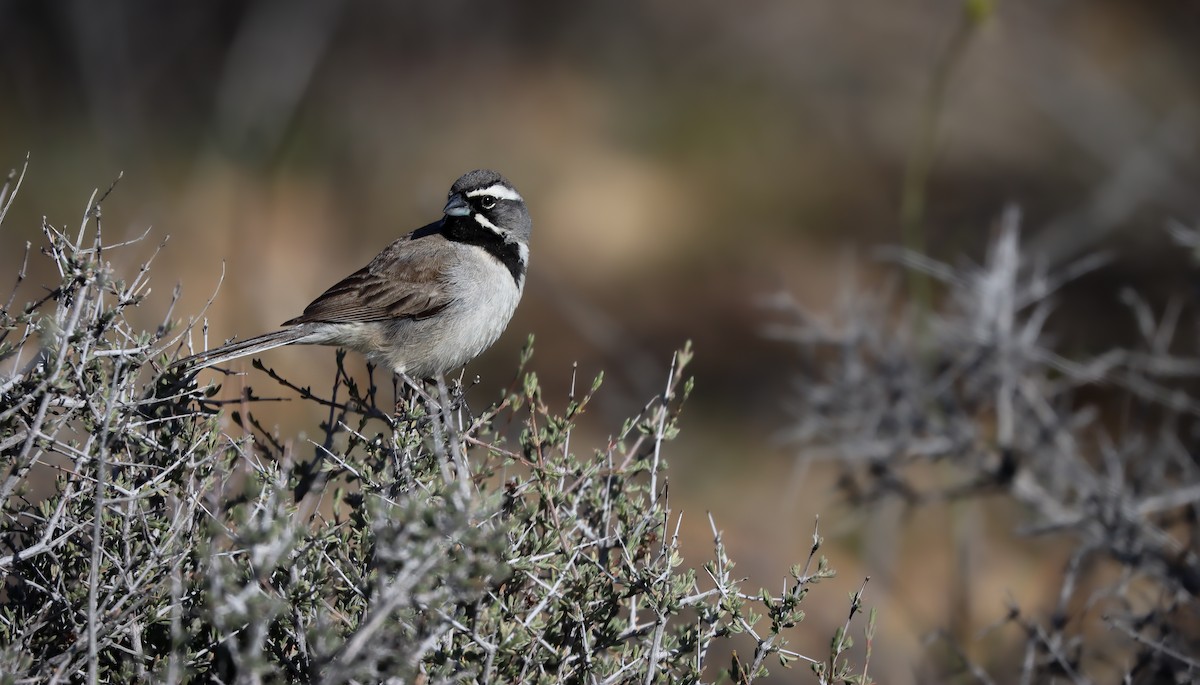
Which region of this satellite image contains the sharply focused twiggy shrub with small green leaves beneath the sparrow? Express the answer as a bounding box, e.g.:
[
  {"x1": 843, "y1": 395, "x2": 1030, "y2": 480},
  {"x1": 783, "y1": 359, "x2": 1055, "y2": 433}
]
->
[{"x1": 0, "y1": 169, "x2": 871, "y2": 683}]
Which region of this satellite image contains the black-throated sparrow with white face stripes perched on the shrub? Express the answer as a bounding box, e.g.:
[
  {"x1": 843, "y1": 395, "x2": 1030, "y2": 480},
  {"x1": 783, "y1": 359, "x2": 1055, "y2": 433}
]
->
[{"x1": 174, "y1": 169, "x2": 533, "y2": 378}]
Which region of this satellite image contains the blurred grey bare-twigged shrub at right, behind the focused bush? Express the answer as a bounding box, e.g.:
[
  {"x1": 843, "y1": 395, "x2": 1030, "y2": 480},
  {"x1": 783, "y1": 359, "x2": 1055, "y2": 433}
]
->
[{"x1": 770, "y1": 210, "x2": 1200, "y2": 683}]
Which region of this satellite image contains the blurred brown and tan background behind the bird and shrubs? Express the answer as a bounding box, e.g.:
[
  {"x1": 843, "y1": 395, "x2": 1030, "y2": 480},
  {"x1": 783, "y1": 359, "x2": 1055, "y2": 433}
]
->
[{"x1": 0, "y1": 0, "x2": 1200, "y2": 684}]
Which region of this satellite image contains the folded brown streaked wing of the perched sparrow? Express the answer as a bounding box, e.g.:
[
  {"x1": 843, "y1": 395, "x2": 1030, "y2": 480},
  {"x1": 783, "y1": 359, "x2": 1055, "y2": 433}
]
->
[{"x1": 283, "y1": 224, "x2": 454, "y2": 326}]
